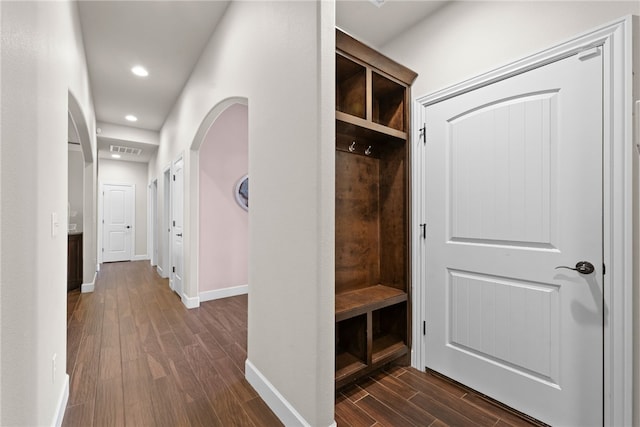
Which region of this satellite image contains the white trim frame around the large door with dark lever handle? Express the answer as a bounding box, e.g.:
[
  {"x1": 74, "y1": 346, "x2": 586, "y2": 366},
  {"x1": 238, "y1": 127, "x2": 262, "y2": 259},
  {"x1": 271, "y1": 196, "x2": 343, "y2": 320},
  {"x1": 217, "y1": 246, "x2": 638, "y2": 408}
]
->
[{"x1": 411, "y1": 16, "x2": 635, "y2": 426}]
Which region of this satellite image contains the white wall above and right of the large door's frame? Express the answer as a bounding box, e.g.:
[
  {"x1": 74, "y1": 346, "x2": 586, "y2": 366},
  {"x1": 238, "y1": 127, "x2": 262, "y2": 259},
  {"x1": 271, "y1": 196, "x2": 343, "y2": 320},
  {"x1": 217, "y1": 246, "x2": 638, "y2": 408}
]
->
[{"x1": 381, "y1": 1, "x2": 640, "y2": 425}]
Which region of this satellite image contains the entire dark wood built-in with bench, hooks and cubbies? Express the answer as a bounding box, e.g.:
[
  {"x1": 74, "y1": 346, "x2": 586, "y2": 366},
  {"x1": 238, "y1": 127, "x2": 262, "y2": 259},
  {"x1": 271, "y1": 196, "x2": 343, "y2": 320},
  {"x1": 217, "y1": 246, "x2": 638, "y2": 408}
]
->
[{"x1": 335, "y1": 30, "x2": 416, "y2": 388}]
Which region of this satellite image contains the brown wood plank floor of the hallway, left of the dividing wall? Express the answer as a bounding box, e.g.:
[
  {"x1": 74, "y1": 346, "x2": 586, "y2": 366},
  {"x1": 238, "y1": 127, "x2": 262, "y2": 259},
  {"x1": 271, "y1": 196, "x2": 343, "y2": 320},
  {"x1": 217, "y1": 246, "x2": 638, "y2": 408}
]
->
[{"x1": 63, "y1": 261, "x2": 282, "y2": 427}]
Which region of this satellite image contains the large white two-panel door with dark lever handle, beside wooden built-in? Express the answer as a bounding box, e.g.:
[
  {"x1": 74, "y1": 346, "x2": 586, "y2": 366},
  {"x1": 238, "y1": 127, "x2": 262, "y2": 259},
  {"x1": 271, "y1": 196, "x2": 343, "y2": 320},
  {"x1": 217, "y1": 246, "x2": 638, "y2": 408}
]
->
[{"x1": 421, "y1": 51, "x2": 604, "y2": 426}]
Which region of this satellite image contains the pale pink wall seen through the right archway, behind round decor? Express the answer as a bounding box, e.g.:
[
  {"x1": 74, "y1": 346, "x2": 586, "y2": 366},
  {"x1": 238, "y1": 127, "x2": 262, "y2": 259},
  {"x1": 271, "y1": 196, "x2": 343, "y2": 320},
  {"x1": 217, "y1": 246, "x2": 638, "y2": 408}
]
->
[{"x1": 199, "y1": 104, "x2": 251, "y2": 293}]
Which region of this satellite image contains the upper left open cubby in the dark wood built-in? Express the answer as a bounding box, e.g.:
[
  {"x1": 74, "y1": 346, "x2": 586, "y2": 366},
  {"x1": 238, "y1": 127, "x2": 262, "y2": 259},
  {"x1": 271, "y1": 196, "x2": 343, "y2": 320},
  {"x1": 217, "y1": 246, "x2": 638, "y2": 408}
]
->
[{"x1": 336, "y1": 54, "x2": 367, "y2": 119}]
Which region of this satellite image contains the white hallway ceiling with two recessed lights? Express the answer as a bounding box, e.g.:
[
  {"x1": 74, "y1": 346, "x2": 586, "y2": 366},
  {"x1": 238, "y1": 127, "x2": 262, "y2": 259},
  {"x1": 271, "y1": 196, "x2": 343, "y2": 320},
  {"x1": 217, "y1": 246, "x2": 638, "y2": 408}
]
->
[{"x1": 78, "y1": 1, "x2": 229, "y2": 130}]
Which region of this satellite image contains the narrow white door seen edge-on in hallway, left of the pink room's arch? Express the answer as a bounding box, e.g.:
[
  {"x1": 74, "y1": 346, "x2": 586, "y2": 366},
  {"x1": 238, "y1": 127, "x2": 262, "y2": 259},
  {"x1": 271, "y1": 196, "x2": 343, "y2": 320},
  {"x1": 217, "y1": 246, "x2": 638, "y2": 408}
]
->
[{"x1": 171, "y1": 158, "x2": 184, "y2": 297}]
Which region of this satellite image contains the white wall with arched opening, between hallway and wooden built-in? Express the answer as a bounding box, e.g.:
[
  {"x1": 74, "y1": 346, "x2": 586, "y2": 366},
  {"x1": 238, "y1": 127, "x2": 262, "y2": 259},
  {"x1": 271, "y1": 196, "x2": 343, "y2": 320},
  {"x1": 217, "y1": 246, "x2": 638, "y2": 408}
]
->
[{"x1": 150, "y1": 1, "x2": 335, "y2": 426}]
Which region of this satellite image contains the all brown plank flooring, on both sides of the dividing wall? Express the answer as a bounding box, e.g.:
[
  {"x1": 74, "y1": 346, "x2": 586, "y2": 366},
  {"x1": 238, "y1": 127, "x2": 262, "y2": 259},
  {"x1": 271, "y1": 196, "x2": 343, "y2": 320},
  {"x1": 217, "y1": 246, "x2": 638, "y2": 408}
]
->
[{"x1": 63, "y1": 261, "x2": 536, "y2": 427}]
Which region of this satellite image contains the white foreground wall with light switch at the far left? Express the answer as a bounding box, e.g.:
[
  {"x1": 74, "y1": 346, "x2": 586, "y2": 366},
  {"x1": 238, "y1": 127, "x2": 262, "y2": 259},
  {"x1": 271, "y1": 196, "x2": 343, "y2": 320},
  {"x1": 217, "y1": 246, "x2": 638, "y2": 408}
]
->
[{"x1": 0, "y1": 2, "x2": 95, "y2": 425}]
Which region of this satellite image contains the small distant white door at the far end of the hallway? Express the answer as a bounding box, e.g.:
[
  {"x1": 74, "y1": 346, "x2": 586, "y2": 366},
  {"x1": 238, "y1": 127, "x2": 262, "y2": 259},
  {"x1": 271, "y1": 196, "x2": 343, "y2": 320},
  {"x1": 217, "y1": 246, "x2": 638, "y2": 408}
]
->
[{"x1": 102, "y1": 184, "x2": 135, "y2": 262}]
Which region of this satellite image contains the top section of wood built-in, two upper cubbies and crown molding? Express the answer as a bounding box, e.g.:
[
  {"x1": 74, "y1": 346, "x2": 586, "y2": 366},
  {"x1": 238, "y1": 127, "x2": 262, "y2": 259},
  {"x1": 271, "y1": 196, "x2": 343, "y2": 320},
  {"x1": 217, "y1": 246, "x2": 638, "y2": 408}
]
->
[{"x1": 336, "y1": 30, "x2": 416, "y2": 139}]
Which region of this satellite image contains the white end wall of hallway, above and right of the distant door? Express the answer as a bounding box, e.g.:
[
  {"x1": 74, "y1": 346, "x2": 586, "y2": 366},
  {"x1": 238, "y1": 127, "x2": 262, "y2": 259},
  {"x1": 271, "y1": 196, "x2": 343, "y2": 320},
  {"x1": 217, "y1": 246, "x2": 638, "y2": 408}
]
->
[{"x1": 98, "y1": 159, "x2": 150, "y2": 260}]
